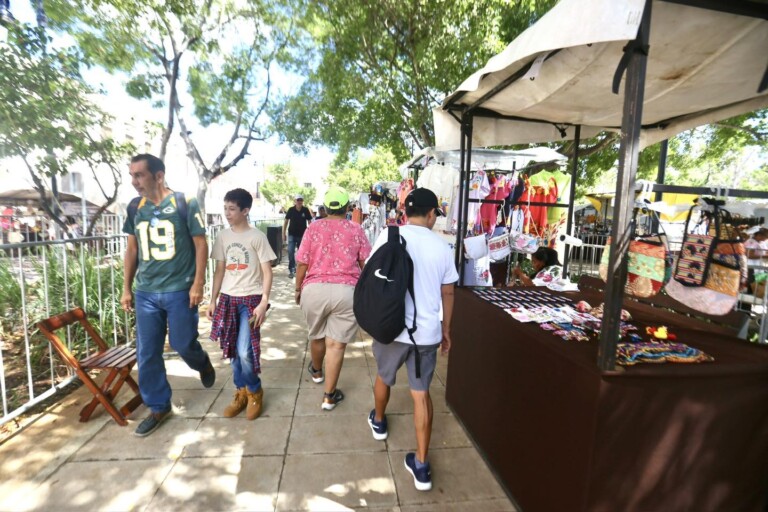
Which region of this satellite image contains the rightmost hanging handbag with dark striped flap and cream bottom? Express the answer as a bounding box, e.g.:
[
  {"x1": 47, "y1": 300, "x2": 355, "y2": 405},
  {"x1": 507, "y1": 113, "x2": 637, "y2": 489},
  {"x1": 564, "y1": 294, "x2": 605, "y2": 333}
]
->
[{"x1": 664, "y1": 204, "x2": 746, "y2": 315}]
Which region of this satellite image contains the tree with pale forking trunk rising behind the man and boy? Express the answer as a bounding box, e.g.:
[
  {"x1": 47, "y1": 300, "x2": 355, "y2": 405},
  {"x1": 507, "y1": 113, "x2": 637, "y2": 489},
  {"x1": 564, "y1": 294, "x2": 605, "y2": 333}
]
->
[{"x1": 52, "y1": 0, "x2": 304, "y2": 208}]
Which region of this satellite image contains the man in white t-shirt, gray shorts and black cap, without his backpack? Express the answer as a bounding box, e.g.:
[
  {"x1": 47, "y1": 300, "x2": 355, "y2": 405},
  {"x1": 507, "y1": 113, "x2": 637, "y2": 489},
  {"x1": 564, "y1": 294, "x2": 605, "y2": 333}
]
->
[{"x1": 368, "y1": 188, "x2": 459, "y2": 491}]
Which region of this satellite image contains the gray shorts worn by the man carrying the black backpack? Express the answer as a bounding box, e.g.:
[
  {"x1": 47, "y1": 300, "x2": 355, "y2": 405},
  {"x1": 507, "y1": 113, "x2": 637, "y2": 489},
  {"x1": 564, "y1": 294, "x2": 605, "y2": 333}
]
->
[{"x1": 373, "y1": 340, "x2": 440, "y2": 391}]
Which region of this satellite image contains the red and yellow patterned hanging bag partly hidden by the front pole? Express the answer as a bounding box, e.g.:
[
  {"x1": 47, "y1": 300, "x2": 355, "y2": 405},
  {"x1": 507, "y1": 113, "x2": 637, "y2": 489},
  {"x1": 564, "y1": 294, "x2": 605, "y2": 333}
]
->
[{"x1": 599, "y1": 209, "x2": 669, "y2": 298}]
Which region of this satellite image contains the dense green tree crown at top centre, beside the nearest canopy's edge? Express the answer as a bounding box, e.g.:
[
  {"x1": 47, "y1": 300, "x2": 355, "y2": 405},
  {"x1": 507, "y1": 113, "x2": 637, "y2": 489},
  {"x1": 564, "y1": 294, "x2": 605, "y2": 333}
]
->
[{"x1": 273, "y1": 0, "x2": 556, "y2": 161}]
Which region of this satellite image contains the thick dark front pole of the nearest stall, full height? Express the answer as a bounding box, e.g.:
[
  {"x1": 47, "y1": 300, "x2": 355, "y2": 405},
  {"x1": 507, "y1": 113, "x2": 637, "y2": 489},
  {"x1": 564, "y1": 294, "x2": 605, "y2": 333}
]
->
[{"x1": 597, "y1": 0, "x2": 651, "y2": 371}]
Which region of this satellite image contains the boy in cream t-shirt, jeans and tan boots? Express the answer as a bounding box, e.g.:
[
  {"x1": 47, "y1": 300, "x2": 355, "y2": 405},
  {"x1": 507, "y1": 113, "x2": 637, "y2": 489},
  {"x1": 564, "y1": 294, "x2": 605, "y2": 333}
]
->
[{"x1": 207, "y1": 188, "x2": 276, "y2": 420}]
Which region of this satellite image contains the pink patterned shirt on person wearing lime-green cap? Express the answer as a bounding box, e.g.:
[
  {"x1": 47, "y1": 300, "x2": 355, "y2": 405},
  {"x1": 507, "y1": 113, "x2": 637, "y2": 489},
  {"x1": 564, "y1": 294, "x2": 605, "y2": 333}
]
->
[{"x1": 296, "y1": 219, "x2": 371, "y2": 286}]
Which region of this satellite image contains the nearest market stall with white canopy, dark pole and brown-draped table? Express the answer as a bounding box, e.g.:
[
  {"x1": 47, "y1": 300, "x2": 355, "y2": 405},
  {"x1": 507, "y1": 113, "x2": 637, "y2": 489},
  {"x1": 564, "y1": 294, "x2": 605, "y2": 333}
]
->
[{"x1": 435, "y1": 0, "x2": 768, "y2": 511}]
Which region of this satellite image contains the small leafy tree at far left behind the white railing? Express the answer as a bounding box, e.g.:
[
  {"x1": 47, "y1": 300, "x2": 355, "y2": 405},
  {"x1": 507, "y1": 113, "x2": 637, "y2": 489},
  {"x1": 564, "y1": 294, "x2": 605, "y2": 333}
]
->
[{"x1": 0, "y1": 24, "x2": 133, "y2": 232}]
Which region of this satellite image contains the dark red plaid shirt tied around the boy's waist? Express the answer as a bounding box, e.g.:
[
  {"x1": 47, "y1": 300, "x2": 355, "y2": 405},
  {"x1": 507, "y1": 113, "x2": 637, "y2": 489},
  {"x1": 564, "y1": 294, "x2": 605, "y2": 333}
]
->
[{"x1": 211, "y1": 293, "x2": 261, "y2": 374}]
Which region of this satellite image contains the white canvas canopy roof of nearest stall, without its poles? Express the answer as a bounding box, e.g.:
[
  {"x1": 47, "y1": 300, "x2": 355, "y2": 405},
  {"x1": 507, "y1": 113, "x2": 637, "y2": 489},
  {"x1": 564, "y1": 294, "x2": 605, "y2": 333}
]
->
[{"x1": 434, "y1": 0, "x2": 768, "y2": 149}]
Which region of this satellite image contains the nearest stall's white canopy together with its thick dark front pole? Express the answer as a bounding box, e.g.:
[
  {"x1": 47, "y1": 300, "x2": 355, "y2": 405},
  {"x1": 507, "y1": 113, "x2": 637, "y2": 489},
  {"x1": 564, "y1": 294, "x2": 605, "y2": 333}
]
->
[{"x1": 434, "y1": 0, "x2": 768, "y2": 370}]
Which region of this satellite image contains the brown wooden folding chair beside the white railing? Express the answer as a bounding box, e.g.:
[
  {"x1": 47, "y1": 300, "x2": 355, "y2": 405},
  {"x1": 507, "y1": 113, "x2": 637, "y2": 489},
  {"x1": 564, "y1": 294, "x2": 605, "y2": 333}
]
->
[{"x1": 37, "y1": 308, "x2": 142, "y2": 426}]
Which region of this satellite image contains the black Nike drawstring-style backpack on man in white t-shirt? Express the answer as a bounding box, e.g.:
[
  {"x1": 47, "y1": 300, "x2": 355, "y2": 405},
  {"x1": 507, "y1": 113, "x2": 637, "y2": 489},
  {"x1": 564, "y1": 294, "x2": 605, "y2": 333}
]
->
[{"x1": 352, "y1": 226, "x2": 421, "y2": 378}]
